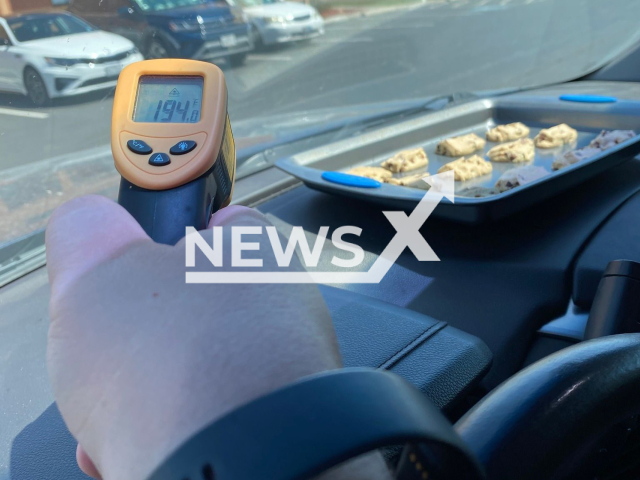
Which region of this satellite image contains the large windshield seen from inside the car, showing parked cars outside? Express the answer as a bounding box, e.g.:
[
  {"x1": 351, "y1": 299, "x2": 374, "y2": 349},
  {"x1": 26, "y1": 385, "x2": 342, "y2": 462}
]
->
[{"x1": 0, "y1": 0, "x2": 640, "y2": 284}]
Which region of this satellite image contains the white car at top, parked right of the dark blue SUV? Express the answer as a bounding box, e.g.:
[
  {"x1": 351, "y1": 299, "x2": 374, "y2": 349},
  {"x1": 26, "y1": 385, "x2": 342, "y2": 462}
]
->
[{"x1": 228, "y1": 0, "x2": 324, "y2": 45}]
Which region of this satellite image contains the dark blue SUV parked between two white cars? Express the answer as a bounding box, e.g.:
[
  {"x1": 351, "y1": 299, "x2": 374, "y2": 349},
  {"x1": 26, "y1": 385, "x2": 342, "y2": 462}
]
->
[{"x1": 69, "y1": 0, "x2": 253, "y2": 65}]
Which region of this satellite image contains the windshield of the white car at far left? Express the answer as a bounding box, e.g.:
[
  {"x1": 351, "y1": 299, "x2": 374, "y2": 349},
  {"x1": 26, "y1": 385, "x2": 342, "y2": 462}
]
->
[{"x1": 8, "y1": 15, "x2": 93, "y2": 42}]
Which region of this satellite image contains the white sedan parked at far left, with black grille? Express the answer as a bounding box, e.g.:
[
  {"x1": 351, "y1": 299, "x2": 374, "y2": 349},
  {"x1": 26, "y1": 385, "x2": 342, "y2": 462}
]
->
[{"x1": 0, "y1": 12, "x2": 143, "y2": 106}]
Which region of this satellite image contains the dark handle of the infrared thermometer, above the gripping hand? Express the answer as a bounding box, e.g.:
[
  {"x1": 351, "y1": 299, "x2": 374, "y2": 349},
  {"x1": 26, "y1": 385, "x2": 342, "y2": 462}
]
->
[{"x1": 118, "y1": 157, "x2": 231, "y2": 245}]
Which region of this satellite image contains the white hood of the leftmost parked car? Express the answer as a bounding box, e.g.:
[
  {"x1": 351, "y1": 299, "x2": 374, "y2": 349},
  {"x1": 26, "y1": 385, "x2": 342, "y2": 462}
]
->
[{"x1": 21, "y1": 31, "x2": 133, "y2": 58}]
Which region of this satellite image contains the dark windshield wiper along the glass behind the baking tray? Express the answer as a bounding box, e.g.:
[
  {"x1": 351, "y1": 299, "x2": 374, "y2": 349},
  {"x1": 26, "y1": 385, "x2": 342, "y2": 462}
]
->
[{"x1": 236, "y1": 92, "x2": 482, "y2": 166}]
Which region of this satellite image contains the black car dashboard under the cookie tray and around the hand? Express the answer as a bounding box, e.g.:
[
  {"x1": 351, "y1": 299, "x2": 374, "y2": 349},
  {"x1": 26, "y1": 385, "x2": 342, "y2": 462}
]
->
[{"x1": 6, "y1": 82, "x2": 640, "y2": 480}]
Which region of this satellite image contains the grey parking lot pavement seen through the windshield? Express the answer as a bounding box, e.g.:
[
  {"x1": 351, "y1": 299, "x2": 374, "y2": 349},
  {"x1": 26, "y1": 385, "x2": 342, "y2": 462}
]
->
[{"x1": 0, "y1": 0, "x2": 640, "y2": 174}]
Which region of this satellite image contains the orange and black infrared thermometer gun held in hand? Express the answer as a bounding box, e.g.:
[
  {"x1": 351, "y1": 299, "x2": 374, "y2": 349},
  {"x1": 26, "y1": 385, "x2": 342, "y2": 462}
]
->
[{"x1": 111, "y1": 59, "x2": 236, "y2": 245}]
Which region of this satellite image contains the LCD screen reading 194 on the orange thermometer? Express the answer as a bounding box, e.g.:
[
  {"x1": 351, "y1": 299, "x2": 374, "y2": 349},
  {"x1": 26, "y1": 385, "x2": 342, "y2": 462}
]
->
[{"x1": 133, "y1": 75, "x2": 204, "y2": 123}]
